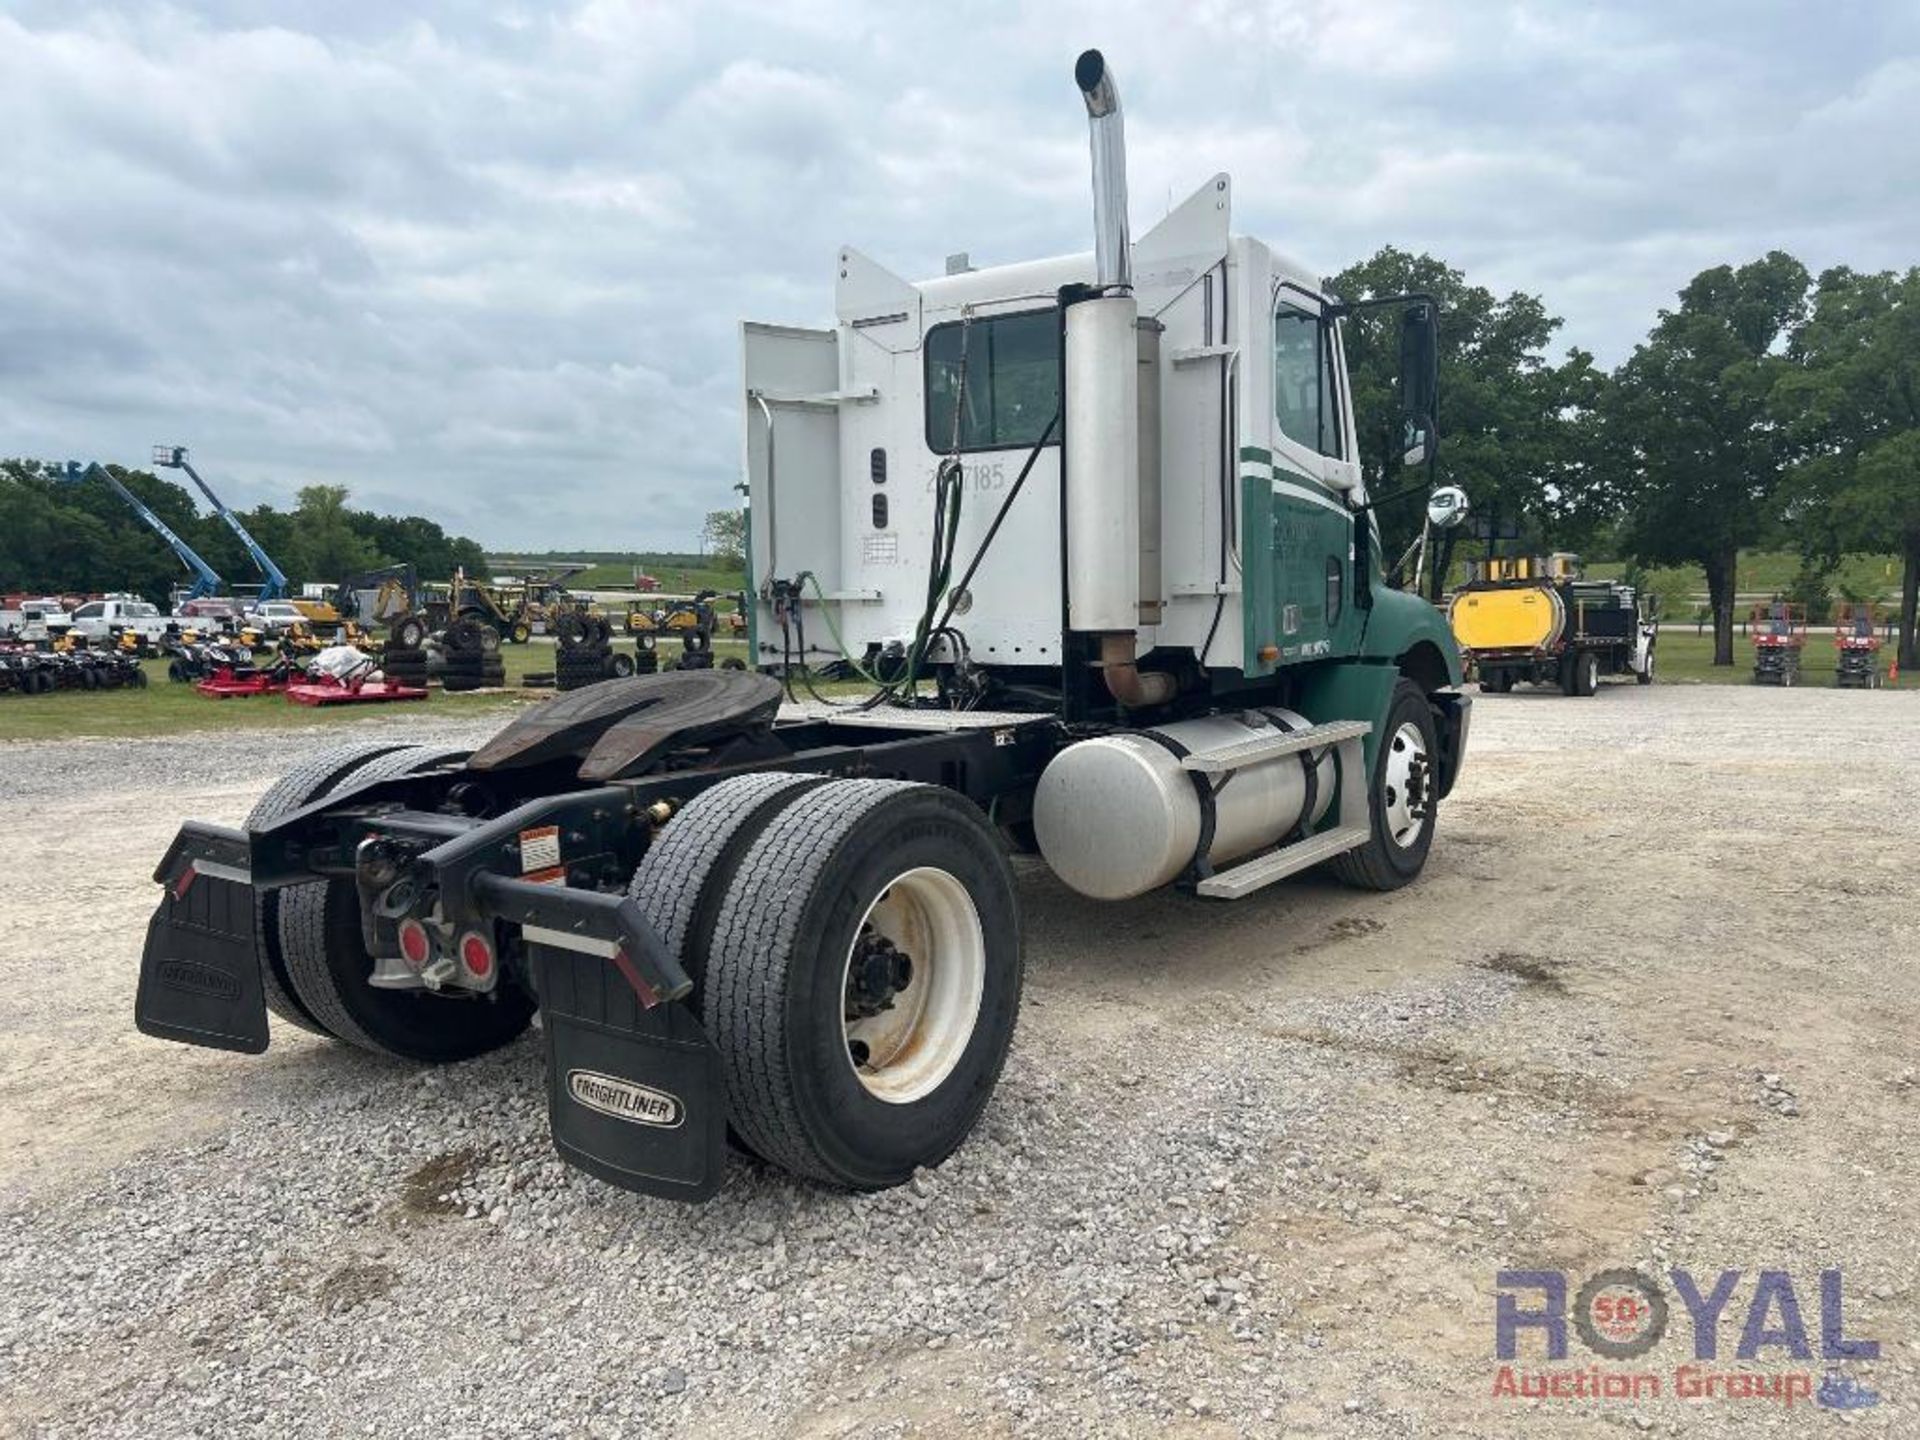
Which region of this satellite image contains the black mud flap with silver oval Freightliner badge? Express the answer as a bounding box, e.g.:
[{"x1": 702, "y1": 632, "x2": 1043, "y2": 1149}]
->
[{"x1": 528, "y1": 945, "x2": 726, "y2": 1200}]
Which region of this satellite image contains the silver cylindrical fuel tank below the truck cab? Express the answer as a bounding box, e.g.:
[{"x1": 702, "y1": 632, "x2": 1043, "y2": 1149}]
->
[{"x1": 1033, "y1": 708, "x2": 1336, "y2": 900}]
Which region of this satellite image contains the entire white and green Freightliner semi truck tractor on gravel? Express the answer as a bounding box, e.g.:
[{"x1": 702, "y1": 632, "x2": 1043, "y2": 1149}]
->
[{"x1": 136, "y1": 52, "x2": 1469, "y2": 1200}]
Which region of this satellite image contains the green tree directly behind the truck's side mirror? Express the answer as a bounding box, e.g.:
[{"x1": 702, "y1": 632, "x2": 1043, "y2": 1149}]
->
[{"x1": 1327, "y1": 246, "x2": 1605, "y2": 595}]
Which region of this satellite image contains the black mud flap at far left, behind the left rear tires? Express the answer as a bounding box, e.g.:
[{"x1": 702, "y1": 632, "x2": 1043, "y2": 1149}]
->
[{"x1": 132, "y1": 822, "x2": 267, "y2": 1054}]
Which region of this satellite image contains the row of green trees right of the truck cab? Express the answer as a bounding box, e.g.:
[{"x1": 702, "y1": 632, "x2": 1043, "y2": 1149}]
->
[{"x1": 1327, "y1": 250, "x2": 1920, "y2": 666}]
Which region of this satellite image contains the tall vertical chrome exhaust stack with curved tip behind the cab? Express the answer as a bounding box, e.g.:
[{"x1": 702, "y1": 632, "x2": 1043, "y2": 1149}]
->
[{"x1": 1064, "y1": 50, "x2": 1175, "y2": 708}]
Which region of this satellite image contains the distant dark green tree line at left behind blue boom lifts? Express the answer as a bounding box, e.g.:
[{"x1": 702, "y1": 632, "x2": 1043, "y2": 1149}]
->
[{"x1": 0, "y1": 459, "x2": 488, "y2": 605}]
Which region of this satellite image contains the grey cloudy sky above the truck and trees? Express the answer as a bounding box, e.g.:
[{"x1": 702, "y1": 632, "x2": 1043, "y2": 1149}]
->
[{"x1": 0, "y1": 0, "x2": 1920, "y2": 549}]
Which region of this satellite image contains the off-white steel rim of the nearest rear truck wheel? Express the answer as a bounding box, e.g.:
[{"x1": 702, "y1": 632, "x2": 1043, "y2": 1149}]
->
[{"x1": 839, "y1": 866, "x2": 987, "y2": 1106}]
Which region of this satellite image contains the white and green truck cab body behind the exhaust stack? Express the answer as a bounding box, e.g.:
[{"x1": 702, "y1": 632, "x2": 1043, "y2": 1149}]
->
[{"x1": 741, "y1": 192, "x2": 1461, "y2": 733}]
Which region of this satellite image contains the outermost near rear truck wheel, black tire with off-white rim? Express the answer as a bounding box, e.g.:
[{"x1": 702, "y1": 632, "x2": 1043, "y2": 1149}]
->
[{"x1": 701, "y1": 780, "x2": 1021, "y2": 1188}]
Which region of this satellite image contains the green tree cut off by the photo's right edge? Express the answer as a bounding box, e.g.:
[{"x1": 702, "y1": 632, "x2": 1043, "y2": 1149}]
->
[{"x1": 1774, "y1": 267, "x2": 1920, "y2": 668}]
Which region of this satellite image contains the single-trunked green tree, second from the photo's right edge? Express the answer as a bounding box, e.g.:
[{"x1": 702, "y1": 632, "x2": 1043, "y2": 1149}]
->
[{"x1": 1603, "y1": 250, "x2": 1809, "y2": 664}]
